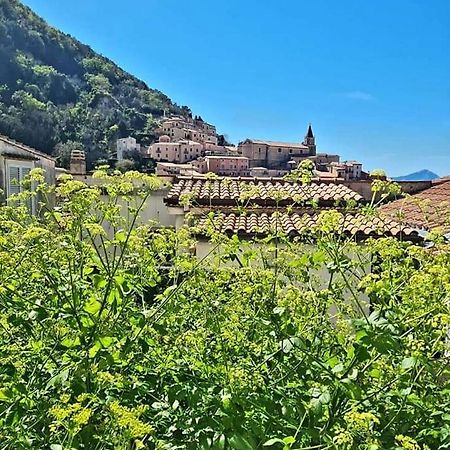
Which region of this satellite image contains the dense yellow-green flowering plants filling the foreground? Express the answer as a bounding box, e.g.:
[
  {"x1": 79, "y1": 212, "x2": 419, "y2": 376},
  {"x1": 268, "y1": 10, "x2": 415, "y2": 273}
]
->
[{"x1": 0, "y1": 171, "x2": 450, "y2": 450}]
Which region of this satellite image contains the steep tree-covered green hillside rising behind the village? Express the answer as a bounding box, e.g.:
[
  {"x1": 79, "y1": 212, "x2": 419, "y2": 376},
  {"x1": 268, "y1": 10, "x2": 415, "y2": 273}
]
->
[{"x1": 0, "y1": 0, "x2": 190, "y2": 169}]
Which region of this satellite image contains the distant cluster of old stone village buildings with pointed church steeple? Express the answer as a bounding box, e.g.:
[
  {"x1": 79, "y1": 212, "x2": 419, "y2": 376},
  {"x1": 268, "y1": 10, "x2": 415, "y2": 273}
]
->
[{"x1": 112, "y1": 116, "x2": 368, "y2": 181}]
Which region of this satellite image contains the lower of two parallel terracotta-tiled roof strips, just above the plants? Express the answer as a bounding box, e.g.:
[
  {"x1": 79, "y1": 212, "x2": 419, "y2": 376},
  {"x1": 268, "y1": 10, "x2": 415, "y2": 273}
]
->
[{"x1": 197, "y1": 211, "x2": 419, "y2": 240}]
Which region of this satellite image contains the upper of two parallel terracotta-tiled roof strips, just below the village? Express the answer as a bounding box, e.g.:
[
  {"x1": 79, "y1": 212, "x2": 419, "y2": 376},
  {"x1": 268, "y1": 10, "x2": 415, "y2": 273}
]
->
[{"x1": 165, "y1": 177, "x2": 363, "y2": 207}]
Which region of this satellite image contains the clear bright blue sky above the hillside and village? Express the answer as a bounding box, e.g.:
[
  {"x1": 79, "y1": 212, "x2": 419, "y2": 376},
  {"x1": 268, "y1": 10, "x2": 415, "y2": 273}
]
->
[{"x1": 24, "y1": 0, "x2": 450, "y2": 176}]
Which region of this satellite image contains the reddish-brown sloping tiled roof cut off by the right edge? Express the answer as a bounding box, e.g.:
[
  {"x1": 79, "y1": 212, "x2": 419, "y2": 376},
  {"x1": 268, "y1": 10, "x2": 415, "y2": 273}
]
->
[{"x1": 380, "y1": 181, "x2": 450, "y2": 233}]
